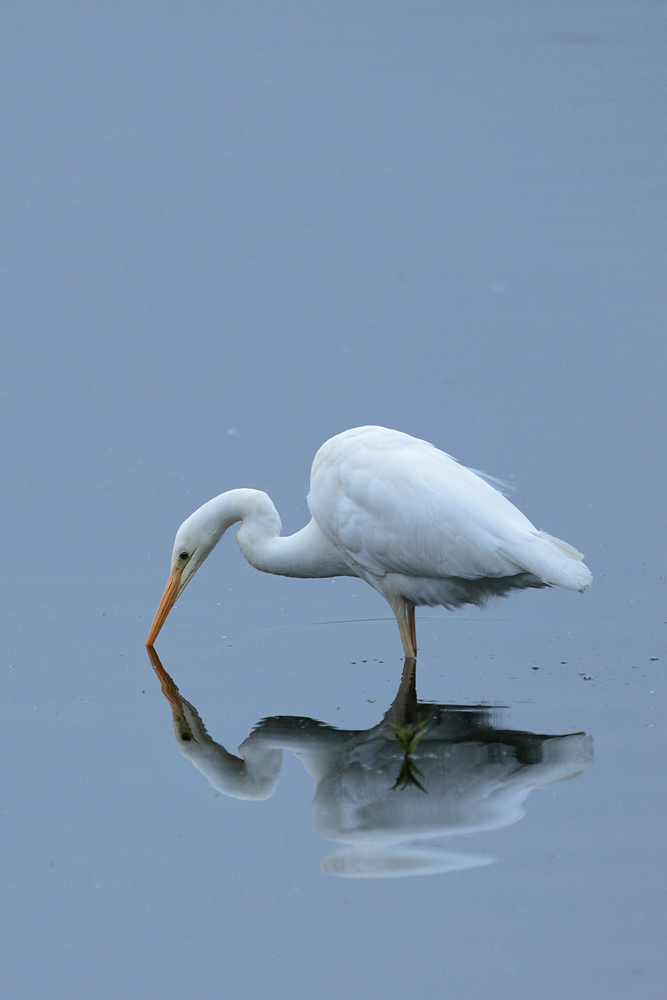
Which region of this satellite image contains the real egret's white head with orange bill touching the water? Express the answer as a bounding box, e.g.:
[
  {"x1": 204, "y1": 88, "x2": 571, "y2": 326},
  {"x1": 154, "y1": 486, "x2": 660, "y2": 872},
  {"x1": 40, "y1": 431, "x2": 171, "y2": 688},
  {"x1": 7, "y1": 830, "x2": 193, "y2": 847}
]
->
[{"x1": 146, "y1": 501, "x2": 223, "y2": 647}]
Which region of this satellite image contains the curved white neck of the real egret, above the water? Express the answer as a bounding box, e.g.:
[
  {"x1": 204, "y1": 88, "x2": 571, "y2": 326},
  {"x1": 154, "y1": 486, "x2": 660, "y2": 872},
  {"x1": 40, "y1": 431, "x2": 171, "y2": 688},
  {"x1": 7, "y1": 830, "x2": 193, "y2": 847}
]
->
[{"x1": 200, "y1": 489, "x2": 355, "y2": 577}]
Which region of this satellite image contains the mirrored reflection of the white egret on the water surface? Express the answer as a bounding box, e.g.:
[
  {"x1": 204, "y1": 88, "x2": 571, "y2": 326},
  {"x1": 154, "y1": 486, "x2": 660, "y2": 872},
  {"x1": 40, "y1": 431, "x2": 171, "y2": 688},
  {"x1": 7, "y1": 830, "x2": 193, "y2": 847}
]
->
[{"x1": 149, "y1": 650, "x2": 593, "y2": 878}]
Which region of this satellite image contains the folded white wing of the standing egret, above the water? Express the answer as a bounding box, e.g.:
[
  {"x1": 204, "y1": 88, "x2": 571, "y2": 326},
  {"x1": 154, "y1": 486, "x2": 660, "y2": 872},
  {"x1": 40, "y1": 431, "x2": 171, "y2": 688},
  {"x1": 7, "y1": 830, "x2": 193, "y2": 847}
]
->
[{"x1": 309, "y1": 427, "x2": 539, "y2": 579}]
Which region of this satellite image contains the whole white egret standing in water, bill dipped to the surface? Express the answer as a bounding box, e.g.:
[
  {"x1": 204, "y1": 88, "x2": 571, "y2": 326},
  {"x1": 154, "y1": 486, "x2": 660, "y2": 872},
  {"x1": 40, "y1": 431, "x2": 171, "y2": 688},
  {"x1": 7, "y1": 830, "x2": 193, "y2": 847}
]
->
[{"x1": 146, "y1": 427, "x2": 592, "y2": 656}]
